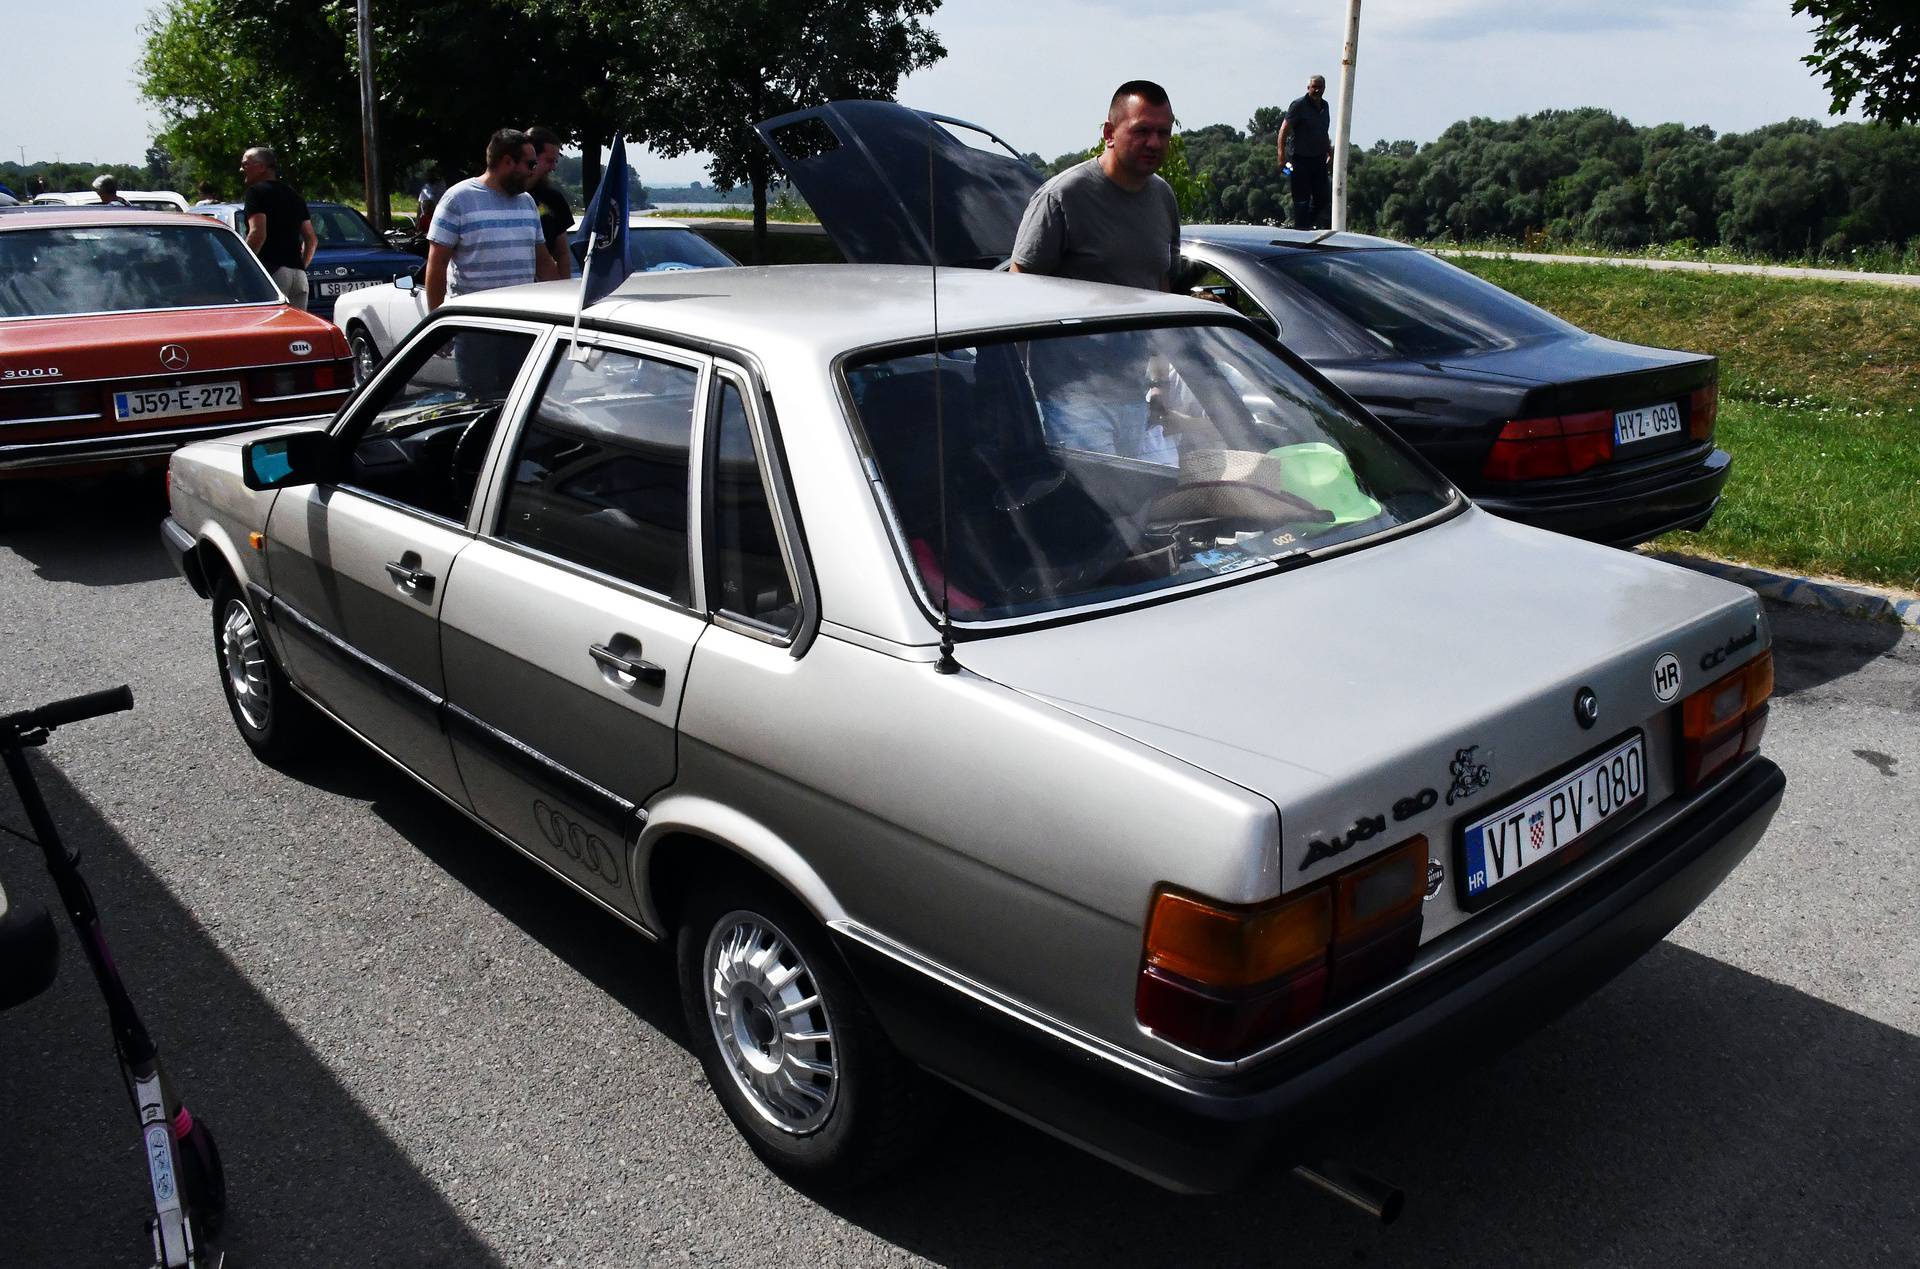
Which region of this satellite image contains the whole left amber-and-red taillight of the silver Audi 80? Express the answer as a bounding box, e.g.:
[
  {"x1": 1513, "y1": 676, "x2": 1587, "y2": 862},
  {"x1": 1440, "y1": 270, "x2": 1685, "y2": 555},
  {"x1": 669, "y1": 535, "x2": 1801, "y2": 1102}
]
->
[{"x1": 1135, "y1": 837, "x2": 1427, "y2": 1058}]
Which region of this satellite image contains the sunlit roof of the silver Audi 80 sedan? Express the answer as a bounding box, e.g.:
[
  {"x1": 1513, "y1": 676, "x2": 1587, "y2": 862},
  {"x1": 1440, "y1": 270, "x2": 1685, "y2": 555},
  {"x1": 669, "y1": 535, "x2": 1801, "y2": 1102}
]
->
[{"x1": 447, "y1": 265, "x2": 1233, "y2": 357}]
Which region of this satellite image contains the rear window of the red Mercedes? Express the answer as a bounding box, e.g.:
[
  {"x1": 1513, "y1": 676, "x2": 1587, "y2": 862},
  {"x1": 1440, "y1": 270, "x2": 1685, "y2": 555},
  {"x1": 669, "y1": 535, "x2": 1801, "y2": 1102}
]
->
[{"x1": 0, "y1": 225, "x2": 280, "y2": 317}]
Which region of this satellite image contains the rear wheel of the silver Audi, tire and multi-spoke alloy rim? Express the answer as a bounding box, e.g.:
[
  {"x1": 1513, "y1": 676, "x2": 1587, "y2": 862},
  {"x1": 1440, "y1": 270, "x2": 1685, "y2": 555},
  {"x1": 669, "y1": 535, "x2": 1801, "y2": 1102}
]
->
[{"x1": 678, "y1": 881, "x2": 927, "y2": 1190}]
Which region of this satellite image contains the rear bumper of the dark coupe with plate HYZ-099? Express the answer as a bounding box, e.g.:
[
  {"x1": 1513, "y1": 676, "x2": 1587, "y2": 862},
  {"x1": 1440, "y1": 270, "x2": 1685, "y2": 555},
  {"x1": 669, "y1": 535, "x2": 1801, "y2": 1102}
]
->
[{"x1": 1473, "y1": 449, "x2": 1734, "y2": 547}]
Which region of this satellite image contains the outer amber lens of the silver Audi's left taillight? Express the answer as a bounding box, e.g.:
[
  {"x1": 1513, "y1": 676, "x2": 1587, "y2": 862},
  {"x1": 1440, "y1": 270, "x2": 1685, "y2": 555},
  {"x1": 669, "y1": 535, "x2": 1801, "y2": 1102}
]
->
[{"x1": 1146, "y1": 887, "x2": 1332, "y2": 987}]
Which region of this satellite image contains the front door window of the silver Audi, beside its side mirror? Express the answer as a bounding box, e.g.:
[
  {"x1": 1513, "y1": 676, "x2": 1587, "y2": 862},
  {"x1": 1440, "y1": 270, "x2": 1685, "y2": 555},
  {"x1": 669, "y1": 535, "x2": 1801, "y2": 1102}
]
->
[{"x1": 346, "y1": 323, "x2": 534, "y2": 522}]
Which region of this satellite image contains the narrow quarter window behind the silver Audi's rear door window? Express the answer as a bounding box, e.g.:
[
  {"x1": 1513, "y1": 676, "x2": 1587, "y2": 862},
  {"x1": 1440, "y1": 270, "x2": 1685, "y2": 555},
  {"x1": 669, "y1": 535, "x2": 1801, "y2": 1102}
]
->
[{"x1": 708, "y1": 380, "x2": 801, "y2": 634}]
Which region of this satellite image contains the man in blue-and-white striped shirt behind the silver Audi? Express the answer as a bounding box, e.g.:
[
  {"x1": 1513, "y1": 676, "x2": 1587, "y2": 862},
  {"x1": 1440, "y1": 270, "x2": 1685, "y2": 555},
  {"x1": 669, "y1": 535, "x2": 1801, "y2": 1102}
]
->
[{"x1": 426, "y1": 129, "x2": 563, "y2": 311}]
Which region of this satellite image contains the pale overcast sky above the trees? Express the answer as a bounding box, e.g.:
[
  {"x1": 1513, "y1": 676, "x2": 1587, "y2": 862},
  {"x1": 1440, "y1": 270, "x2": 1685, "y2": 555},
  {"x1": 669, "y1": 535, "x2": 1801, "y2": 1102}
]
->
[{"x1": 0, "y1": 0, "x2": 1858, "y2": 184}]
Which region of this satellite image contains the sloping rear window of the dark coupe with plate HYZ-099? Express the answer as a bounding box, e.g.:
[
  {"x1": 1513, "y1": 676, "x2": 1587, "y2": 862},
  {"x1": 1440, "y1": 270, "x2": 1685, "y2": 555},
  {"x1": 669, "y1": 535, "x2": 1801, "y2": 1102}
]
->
[{"x1": 1261, "y1": 248, "x2": 1572, "y2": 359}]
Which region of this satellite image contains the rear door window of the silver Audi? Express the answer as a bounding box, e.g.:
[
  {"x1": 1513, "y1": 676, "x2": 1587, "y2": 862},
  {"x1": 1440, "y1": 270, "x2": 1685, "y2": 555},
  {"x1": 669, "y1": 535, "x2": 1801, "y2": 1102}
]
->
[{"x1": 499, "y1": 339, "x2": 699, "y2": 605}]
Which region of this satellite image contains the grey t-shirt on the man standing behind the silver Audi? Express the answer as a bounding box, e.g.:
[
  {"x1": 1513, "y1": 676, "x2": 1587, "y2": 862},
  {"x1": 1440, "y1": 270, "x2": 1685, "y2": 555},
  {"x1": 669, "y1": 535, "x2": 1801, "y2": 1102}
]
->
[{"x1": 1014, "y1": 159, "x2": 1181, "y2": 290}]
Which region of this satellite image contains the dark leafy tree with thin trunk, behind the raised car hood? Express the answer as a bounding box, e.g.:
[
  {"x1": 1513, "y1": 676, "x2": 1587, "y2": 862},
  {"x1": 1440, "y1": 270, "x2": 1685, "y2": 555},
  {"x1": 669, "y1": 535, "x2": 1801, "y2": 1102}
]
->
[{"x1": 629, "y1": 0, "x2": 947, "y2": 259}]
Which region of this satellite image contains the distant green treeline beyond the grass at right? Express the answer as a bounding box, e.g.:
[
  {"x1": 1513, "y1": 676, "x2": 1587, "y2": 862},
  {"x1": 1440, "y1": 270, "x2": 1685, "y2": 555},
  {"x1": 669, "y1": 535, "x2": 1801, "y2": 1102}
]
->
[{"x1": 1048, "y1": 108, "x2": 1920, "y2": 257}]
